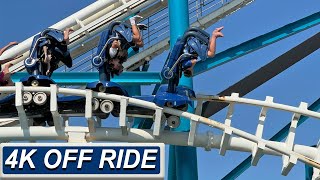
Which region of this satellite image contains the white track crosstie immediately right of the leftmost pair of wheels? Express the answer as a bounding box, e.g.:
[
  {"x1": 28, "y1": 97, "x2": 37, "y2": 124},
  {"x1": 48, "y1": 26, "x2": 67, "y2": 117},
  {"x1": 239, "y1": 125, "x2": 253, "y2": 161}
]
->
[{"x1": 50, "y1": 84, "x2": 63, "y2": 130}]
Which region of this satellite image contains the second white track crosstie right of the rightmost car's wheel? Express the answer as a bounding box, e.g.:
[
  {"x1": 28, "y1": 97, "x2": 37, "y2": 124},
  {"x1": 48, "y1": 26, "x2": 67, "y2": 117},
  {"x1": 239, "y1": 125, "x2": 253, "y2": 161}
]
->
[{"x1": 219, "y1": 93, "x2": 239, "y2": 156}]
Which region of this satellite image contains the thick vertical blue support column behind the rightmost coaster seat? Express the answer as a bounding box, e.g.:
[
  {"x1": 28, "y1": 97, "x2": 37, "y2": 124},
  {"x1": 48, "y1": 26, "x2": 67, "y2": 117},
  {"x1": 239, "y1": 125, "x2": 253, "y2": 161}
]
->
[{"x1": 168, "y1": 0, "x2": 198, "y2": 180}]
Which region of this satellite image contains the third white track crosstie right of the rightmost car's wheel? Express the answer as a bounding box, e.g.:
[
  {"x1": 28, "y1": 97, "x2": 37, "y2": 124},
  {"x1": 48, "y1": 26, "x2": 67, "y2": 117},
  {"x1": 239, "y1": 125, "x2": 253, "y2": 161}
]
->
[{"x1": 251, "y1": 96, "x2": 273, "y2": 166}]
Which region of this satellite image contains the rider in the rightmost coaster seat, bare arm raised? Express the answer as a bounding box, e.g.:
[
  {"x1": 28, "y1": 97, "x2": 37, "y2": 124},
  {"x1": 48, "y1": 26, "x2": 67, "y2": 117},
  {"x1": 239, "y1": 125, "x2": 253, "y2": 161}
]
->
[{"x1": 183, "y1": 27, "x2": 223, "y2": 77}]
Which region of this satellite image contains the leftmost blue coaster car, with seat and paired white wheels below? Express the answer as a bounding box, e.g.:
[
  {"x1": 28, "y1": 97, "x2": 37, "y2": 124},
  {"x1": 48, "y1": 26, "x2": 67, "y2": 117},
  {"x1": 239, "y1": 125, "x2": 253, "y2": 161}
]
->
[{"x1": 21, "y1": 28, "x2": 72, "y2": 126}]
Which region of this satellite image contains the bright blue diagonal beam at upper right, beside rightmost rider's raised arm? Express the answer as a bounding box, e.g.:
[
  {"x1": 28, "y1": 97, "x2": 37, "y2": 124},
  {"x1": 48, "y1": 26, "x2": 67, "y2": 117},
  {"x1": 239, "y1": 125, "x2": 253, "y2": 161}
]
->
[{"x1": 194, "y1": 12, "x2": 320, "y2": 76}]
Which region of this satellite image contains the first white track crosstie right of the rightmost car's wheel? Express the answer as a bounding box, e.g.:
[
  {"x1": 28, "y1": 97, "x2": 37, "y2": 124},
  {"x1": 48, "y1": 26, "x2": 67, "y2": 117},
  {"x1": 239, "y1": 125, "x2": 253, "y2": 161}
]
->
[{"x1": 188, "y1": 100, "x2": 203, "y2": 146}]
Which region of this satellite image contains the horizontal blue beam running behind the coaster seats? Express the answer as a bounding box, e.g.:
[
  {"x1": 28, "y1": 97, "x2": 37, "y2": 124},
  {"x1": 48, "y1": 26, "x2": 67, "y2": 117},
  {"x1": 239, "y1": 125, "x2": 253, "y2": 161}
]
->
[{"x1": 11, "y1": 72, "x2": 162, "y2": 85}]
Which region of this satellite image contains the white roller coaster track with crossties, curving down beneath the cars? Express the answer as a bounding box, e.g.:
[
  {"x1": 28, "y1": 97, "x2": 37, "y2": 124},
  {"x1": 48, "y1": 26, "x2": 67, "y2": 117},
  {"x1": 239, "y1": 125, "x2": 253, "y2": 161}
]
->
[{"x1": 0, "y1": 82, "x2": 320, "y2": 179}]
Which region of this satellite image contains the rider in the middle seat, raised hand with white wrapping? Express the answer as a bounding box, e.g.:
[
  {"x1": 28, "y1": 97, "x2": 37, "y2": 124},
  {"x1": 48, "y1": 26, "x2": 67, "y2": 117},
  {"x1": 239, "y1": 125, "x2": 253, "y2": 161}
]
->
[{"x1": 107, "y1": 15, "x2": 146, "y2": 74}]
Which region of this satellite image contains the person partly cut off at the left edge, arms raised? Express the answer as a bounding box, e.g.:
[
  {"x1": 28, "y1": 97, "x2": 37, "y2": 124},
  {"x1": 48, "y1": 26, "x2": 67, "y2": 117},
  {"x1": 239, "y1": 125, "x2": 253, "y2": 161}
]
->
[{"x1": 0, "y1": 42, "x2": 21, "y2": 86}]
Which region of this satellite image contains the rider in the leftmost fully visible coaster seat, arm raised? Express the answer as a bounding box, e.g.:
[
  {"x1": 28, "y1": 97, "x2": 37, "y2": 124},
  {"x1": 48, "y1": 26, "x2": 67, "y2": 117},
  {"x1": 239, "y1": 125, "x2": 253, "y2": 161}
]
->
[{"x1": 43, "y1": 28, "x2": 73, "y2": 76}]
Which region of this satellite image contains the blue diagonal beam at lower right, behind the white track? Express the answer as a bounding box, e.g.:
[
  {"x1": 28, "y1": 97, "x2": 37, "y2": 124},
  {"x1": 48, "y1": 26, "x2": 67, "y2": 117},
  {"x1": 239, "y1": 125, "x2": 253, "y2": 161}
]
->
[{"x1": 222, "y1": 98, "x2": 320, "y2": 180}]
